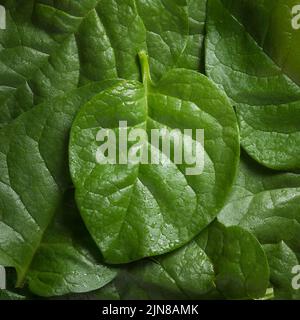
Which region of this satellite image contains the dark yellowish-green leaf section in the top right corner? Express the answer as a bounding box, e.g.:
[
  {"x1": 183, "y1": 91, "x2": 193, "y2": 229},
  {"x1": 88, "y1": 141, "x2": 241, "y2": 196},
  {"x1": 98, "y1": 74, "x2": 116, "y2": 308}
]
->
[{"x1": 217, "y1": 0, "x2": 300, "y2": 85}]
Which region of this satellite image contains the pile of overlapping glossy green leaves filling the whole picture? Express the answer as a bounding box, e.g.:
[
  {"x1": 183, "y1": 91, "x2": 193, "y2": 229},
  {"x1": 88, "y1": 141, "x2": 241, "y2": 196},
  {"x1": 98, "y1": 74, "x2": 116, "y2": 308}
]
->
[{"x1": 0, "y1": 0, "x2": 300, "y2": 299}]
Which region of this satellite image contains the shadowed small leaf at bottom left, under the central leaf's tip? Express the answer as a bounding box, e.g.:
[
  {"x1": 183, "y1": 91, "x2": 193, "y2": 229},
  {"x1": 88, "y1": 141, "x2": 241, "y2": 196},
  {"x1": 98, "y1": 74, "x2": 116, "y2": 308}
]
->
[{"x1": 27, "y1": 192, "x2": 117, "y2": 297}]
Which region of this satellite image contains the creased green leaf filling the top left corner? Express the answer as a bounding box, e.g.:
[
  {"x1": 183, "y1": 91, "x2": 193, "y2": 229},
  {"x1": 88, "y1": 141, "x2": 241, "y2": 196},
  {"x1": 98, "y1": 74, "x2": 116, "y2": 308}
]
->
[{"x1": 0, "y1": 0, "x2": 80, "y2": 127}]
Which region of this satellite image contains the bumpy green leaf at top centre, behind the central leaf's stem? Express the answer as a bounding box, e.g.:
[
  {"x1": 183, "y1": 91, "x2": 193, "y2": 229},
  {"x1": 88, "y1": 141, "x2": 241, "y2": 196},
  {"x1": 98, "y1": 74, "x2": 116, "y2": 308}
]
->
[{"x1": 37, "y1": 0, "x2": 189, "y2": 83}]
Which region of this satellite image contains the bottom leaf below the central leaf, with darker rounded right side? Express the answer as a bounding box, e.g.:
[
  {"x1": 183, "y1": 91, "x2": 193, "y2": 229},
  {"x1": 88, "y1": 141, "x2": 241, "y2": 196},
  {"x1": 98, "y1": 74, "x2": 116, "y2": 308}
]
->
[{"x1": 64, "y1": 222, "x2": 269, "y2": 300}]
